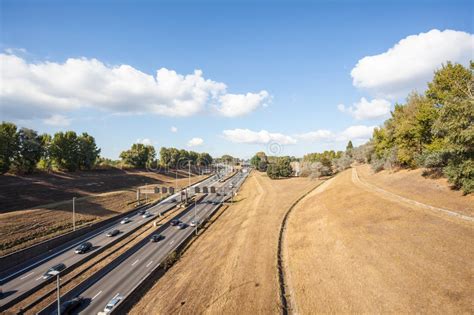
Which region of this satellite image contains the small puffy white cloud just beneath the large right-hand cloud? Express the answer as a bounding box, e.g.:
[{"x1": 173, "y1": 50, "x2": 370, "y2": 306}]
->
[{"x1": 337, "y1": 97, "x2": 390, "y2": 120}]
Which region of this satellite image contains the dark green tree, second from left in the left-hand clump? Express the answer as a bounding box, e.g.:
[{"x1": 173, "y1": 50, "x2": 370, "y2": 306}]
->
[{"x1": 13, "y1": 128, "x2": 42, "y2": 174}]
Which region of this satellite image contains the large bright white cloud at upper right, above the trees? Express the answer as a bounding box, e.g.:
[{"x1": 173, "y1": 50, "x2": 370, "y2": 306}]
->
[{"x1": 351, "y1": 29, "x2": 474, "y2": 98}]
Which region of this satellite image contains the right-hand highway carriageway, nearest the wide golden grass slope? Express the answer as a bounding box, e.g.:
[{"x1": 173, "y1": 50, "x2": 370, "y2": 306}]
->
[{"x1": 72, "y1": 174, "x2": 247, "y2": 314}]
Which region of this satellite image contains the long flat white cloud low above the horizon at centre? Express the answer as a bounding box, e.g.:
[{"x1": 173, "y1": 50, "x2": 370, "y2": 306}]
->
[{"x1": 222, "y1": 129, "x2": 296, "y2": 145}]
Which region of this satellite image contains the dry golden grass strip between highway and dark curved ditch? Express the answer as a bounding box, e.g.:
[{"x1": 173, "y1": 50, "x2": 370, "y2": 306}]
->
[{"x1": 131, "y1": 172, "x2": 319, "y2": 314}]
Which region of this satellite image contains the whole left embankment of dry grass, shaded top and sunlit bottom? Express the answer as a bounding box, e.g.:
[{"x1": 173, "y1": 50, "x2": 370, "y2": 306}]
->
[{"x1": 0, "y1": 170, "x2": 205, "y2": 256}]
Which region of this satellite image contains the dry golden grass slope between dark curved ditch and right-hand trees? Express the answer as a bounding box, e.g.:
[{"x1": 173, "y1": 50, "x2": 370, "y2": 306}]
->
[{"x1": 283, "y1": 166, "x2": 474, "y2": 314}]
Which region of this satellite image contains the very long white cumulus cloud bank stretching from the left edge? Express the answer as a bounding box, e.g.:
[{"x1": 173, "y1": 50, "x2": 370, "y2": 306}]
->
[{"x1": 0, "y1": 51, "x2": 268, "y2": 119}]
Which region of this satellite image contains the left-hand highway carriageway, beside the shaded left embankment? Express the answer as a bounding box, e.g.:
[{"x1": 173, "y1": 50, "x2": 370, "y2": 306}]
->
[{"x1": 0, "y1": 176, "x2": 226, "y2": 310}]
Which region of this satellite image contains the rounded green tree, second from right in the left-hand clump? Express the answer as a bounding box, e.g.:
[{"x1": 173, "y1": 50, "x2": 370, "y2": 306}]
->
[{"x1": 50, "y1": 131, "x2": 79, "y2": 172}]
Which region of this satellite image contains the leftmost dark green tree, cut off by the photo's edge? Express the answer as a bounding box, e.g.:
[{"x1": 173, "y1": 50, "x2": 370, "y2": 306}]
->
[{"x1": 0, "y1": 122, "x2": 19, "y2": 174}]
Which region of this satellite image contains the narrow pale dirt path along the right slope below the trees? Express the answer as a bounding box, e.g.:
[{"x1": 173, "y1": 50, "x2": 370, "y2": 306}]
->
[{"x1": 352, "y1": 168, "x2": 474, "y2": 221}]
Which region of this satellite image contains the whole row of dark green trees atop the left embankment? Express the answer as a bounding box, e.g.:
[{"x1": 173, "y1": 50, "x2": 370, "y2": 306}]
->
[{"x1": 0, "y1": 122, "x2": 100, "y2": 174}]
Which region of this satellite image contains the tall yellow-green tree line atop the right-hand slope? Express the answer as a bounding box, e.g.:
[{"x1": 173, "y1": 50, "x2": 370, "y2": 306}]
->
[{"x1": 354, "y1": 61, "x2": 474, "y2": 194}]
